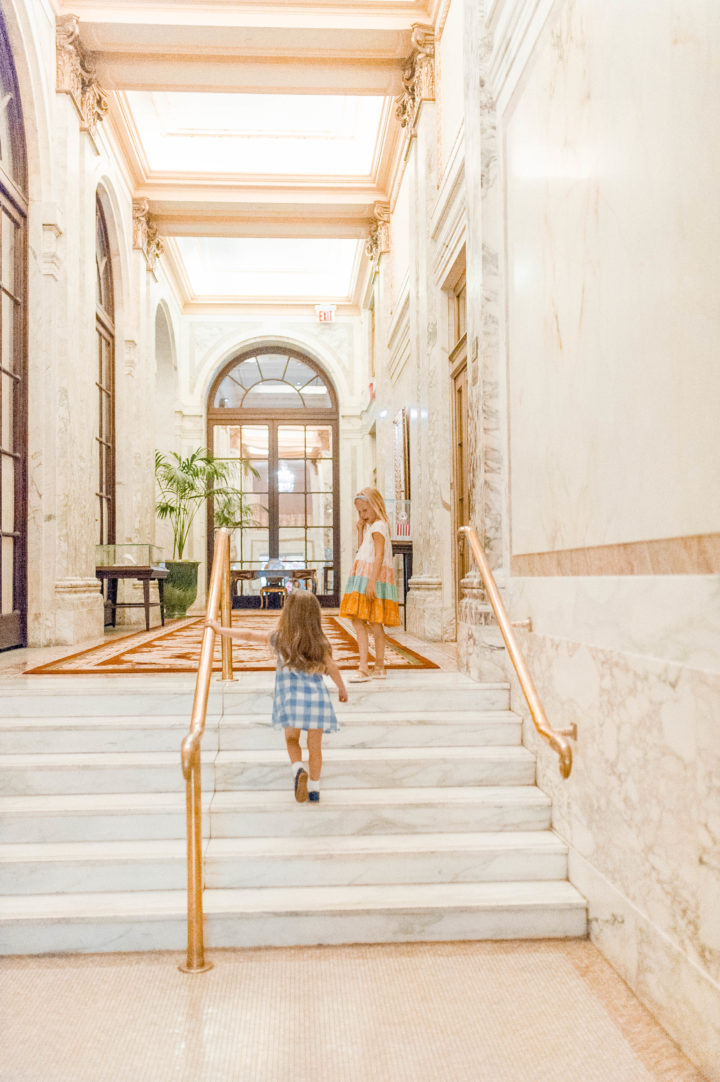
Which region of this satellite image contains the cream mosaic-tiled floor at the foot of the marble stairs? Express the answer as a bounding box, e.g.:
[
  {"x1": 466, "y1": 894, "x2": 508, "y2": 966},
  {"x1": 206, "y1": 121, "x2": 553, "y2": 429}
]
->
[{"x1": 0, "y1": 940, "x2": 704, "y2": 1082}]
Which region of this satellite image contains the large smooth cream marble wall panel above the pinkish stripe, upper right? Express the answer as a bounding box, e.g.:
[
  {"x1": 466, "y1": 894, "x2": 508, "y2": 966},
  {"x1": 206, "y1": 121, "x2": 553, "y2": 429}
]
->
[{"x1": 503, "y1": 0, "x2": 720, "y2": 553}]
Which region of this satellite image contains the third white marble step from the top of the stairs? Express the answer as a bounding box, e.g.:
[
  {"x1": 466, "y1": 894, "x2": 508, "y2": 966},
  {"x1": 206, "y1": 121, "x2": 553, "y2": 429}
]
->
[{"x1": 0, "y1": 747, "x2": 535, "y2": 796}]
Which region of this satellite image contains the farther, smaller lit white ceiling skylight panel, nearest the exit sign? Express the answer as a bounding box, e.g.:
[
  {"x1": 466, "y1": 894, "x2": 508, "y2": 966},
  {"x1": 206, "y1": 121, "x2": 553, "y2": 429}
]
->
[{"x1": 175, "y1": 237, "x2": 359, "y2": 301}]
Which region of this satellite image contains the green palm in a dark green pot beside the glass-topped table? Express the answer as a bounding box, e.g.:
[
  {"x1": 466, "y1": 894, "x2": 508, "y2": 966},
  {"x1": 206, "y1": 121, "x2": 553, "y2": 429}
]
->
[{"x1": 155, "y1": 447, "x2": 254, "y2": 618}]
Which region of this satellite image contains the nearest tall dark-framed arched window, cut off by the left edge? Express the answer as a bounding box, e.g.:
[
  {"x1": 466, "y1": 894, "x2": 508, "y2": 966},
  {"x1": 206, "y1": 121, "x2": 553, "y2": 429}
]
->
[{"x1": 0, "y1": 16, "x2": 27, "y2": 649}]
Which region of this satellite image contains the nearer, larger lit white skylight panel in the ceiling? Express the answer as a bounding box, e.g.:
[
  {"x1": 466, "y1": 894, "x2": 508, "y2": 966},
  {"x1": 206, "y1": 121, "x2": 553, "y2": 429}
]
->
[{"x1": 126, "y1": 91, "x2": 384, "y2": 176}]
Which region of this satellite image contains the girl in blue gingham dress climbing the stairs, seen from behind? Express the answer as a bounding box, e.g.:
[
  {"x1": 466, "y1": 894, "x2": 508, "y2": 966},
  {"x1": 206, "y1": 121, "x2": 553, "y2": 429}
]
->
[{"x1": 207, "y1": 590, "x2": 348, "y2": 804}]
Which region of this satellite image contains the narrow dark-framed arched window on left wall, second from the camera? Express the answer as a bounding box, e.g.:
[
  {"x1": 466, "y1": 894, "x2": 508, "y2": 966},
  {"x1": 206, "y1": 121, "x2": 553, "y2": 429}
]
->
[{"x1": 95, "y1": 199, "x2": 115, "y2": 544}]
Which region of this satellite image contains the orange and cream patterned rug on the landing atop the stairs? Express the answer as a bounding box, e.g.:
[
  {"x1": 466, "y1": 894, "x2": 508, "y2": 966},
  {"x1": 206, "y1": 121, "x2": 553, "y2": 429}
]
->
[{"x1": 27, "y1": 612, "x2": 437, "y2": 675}]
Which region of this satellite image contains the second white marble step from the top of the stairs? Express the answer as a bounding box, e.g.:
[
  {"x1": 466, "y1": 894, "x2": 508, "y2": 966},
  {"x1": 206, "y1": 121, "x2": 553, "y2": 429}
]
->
[{"x1": 0, "y1": 710, "x2": 522, "y2": 755}]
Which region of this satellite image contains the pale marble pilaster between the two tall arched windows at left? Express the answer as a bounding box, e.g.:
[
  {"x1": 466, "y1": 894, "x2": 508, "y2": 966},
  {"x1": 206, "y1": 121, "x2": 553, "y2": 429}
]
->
[{"x1": 28, "y1": 94, "x2": 103, "y2": 646}]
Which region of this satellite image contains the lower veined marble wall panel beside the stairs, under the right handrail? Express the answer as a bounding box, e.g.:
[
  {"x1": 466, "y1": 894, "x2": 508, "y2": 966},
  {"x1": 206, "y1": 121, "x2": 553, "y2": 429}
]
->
[{"x1": 500, "y1": 632, "x2": 720, "y2": 1078}]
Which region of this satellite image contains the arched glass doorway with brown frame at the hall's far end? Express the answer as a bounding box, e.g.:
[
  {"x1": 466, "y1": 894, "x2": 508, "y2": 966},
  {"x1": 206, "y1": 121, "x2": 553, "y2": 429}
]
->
[{"x1": 208, "y1": 346, "x2": 340, "y2": 605}]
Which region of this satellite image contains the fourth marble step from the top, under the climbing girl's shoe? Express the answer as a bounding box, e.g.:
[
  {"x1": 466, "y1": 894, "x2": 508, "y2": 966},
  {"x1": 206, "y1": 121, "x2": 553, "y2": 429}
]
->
[{"x1": 0, "y1": 786, "x2": 550, "y2": 845}]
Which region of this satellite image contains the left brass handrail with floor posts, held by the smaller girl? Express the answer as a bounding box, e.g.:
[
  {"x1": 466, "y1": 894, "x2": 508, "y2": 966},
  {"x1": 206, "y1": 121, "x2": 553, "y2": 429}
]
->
[{"x1": 180, "y1": 529, "x2": 233, "y2": 973}]
